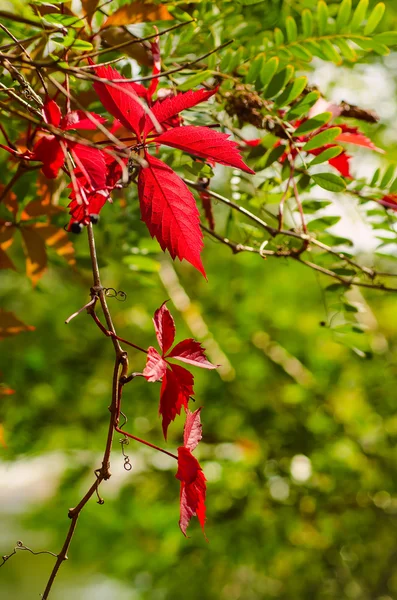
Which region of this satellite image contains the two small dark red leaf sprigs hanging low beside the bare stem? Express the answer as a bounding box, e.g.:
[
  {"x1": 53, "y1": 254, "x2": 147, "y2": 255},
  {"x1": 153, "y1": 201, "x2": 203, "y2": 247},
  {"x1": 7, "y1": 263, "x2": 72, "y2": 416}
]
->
[{"x1": 143, "y1": 302, "x2": 216, "y2": 535}]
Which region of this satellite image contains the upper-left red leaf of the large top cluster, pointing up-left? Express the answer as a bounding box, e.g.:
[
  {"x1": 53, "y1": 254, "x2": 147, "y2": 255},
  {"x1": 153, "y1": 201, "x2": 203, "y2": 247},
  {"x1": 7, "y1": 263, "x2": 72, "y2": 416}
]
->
[{"x1": 90, "y1": 61, "x2": 145, "y2": 138}]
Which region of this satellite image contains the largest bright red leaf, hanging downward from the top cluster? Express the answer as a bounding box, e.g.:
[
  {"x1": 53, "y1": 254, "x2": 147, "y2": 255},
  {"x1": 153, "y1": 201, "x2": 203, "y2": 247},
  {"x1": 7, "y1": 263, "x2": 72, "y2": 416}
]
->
[{"x1": 138, "y1": 154, "x2": 205, "y2": 276}]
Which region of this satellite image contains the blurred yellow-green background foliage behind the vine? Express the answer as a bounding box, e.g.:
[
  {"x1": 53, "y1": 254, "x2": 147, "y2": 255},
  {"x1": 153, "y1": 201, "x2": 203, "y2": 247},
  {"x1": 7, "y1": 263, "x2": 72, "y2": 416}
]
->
[{"x1": 0, "y1": 0, "x2": 397, "y2": 600}]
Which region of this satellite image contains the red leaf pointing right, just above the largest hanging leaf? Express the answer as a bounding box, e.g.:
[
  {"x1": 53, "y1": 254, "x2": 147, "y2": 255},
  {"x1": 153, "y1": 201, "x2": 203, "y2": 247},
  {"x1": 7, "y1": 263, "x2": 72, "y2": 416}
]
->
[{"x1": 156, "y1": 125, "x2": 255, "y2": 173}]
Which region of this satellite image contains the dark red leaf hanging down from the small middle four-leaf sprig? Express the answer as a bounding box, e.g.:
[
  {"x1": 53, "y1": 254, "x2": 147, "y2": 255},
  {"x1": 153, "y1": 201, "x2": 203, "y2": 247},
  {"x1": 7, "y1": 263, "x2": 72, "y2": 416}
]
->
[{"x1": 159, "y1": 365, "x2": 194, "y2": 439}]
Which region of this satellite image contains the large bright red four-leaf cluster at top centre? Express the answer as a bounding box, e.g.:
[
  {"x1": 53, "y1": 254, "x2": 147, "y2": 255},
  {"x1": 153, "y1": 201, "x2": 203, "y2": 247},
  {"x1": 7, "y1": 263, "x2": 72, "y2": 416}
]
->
[{"x1": 89, "y1": 60, "x2": 253, "y2": 275}]
